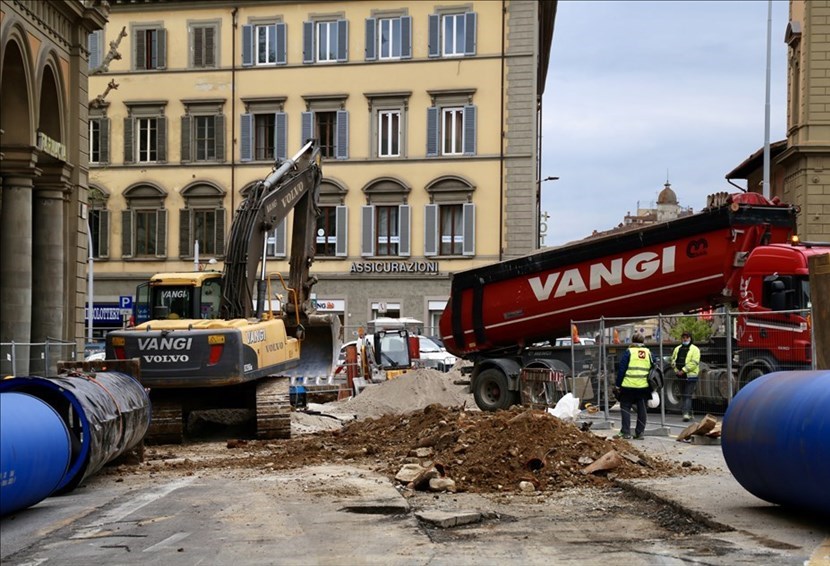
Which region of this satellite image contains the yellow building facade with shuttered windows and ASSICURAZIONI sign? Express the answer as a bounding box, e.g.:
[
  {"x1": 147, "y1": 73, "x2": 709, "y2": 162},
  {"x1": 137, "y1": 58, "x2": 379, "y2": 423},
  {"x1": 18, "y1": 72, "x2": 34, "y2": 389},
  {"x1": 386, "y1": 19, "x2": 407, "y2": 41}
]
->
[{"x1": 85, "y1": 1, "x2": 556, "y2": 340}]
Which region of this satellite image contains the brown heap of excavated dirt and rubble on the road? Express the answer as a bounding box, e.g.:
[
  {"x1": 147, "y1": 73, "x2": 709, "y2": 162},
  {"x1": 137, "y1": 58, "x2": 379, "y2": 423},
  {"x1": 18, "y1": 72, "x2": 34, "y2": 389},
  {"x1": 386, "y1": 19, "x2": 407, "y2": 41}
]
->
[{"x1": 140, "y1": 404, "x2": 688, "y2": 493}]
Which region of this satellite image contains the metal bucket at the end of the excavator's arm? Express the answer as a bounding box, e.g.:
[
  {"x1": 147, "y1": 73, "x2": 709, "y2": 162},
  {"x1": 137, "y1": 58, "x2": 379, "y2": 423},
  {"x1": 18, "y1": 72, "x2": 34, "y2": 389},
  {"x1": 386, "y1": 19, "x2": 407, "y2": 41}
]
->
[{"x1": 283, "y1": 314, "x2": 340, "y2": 383}]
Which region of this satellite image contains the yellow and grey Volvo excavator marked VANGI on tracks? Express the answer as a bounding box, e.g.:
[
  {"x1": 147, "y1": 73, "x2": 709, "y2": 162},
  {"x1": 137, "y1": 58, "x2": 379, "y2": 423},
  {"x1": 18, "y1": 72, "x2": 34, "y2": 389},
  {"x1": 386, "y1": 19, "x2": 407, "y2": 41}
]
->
[{"x1": 106, "y1": 142, "x2": 340, "y2": 443}]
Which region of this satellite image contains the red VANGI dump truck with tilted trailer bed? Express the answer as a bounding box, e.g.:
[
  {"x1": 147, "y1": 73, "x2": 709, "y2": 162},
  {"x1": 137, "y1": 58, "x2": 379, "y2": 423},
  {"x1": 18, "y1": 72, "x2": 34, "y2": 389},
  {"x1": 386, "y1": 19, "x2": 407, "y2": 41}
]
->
[{"x1": 440, "y1": 193, "x2": 830, "y2": 410}]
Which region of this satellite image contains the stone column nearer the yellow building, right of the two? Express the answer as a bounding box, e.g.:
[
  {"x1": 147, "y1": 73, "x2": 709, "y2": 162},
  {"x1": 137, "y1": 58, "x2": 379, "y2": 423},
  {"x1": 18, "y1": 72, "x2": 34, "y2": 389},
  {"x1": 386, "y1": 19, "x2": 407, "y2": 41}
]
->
[{"x1": 31, "y1": 165, "x2": 74, "y2": 373}]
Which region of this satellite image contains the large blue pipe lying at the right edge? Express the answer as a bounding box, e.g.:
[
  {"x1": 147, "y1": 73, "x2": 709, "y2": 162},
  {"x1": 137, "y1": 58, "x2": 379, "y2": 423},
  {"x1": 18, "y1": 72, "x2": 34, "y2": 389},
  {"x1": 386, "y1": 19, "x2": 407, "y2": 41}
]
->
[{"x1": 721, "y1": 370, "x2": 830, "y2": 516}]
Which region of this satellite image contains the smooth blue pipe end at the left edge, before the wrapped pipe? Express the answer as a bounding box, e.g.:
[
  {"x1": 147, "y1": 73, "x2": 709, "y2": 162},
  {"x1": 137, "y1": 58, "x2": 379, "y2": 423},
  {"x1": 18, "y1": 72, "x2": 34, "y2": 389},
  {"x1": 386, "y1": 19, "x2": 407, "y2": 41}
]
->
[{"x1": 0, "y1": 392, "x2": 71, "y2": 516}]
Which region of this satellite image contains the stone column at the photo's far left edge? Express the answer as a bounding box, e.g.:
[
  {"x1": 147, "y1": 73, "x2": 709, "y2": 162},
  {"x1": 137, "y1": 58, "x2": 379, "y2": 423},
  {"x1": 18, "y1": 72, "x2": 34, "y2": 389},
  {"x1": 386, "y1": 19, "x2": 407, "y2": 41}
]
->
[{"x1": 0, "y1": 164, "x2": 36, "y2": 375}]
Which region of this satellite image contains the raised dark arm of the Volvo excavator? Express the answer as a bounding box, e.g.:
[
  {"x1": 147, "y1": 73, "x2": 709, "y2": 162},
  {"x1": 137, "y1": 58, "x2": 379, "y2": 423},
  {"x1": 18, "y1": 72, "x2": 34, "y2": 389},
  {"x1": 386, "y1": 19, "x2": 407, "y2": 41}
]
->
[{"x1": 220, "y1": 141, "x2": 322, "y2": 319}]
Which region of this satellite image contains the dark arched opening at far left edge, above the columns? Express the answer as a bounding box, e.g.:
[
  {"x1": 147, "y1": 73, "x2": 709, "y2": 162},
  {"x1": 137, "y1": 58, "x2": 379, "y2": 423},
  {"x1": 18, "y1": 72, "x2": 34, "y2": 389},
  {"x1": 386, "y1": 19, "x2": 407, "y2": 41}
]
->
[{"x1": 0, "y1": 22, "x2": 35, "y2": 147}]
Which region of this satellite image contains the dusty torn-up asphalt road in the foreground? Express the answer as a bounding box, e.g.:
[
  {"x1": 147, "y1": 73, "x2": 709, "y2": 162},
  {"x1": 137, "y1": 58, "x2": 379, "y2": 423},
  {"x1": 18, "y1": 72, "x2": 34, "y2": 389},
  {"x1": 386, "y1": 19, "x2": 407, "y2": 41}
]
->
[{"x1": 0, "y1": 413, "x2": 830, "y2": 566}]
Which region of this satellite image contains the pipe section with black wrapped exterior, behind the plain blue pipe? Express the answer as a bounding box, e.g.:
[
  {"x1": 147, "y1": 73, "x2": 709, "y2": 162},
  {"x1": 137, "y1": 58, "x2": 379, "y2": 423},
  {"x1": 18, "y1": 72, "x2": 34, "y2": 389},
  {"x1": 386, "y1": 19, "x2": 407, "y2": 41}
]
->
[{"x1": 0, "y1": 371, "x2": 151, "y2": 500}]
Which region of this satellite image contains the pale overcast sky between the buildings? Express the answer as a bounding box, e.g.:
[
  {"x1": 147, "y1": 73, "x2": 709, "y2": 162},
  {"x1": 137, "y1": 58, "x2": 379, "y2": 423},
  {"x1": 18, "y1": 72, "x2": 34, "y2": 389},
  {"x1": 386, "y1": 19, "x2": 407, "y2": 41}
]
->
[{"x1": 542, "y1": 0, "x2": 789, "y2": 246}]
